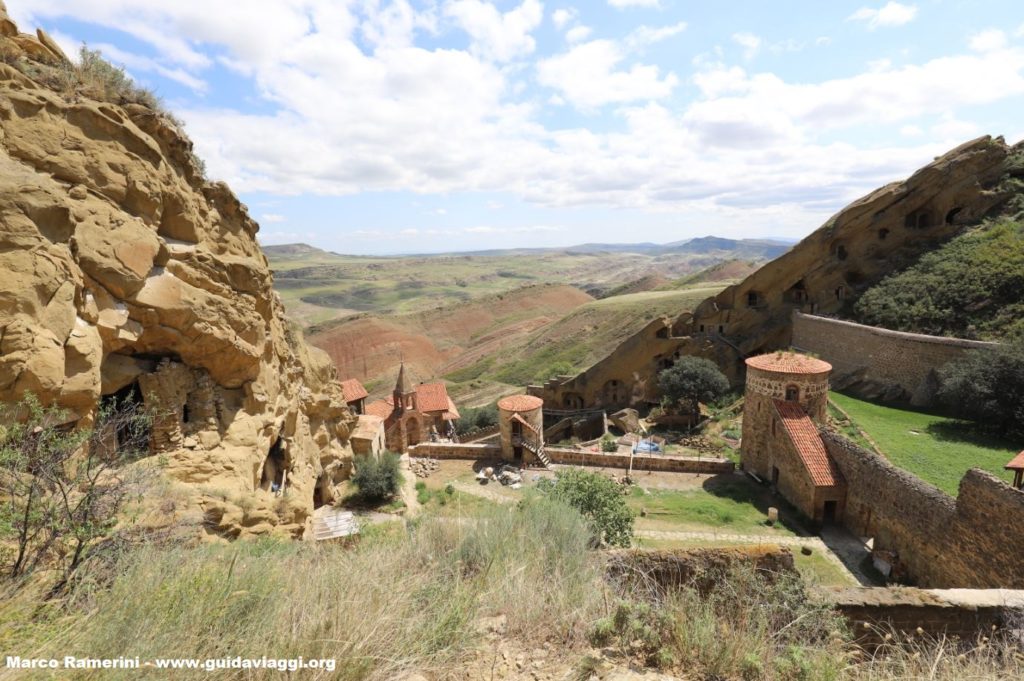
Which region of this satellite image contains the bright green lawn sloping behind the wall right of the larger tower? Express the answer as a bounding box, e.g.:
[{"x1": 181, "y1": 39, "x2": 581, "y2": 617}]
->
[{"x1": 831, "y1": 392, "x2": 1020, "y2": 496}]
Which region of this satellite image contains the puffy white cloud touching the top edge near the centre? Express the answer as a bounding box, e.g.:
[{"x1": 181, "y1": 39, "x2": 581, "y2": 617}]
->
[{"x1": 444, "y1": 0, "x2": 544, "y2": 61}]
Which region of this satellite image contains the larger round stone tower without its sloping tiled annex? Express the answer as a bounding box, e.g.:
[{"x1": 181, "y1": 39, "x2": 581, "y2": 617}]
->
[{"x1": 742, "y1": 351, "x2": 831, "y2": 477}]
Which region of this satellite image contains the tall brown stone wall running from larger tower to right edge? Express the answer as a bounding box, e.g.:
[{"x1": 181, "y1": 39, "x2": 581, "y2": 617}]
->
[{"x1": 822, "y1": 432, "x2": 1024, "y2": 589}]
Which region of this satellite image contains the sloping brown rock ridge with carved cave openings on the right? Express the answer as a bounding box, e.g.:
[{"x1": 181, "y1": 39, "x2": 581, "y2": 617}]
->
[{"x1": 529, "y1": 136, "x2": 1024, "y2": 409}]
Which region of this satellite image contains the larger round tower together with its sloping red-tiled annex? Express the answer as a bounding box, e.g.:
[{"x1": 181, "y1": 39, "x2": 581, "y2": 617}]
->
[{"x1": 741, "y1": 352, "x2": 846, "y2": 523}]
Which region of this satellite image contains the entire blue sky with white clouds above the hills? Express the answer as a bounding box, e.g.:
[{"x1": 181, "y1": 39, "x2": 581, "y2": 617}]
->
[{"x1": 7, "y1": 0, "x2": 1024, "y2": 254}]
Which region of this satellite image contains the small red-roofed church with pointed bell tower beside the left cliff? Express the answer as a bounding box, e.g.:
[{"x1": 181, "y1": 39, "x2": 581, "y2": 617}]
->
[{"x1": 366, "y1": 363, "x2": 459, "y2": 452}]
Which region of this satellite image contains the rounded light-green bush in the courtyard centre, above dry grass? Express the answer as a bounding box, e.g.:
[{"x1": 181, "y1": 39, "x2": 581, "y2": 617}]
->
[{"x1": 541, "y1": 468, "x2": 633, "y2": 547}]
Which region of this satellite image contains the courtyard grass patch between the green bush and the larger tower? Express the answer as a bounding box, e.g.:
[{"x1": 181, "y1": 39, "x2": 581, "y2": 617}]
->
[{"x1": 628, "y1": 478, "x2": 797, "y2": 537}]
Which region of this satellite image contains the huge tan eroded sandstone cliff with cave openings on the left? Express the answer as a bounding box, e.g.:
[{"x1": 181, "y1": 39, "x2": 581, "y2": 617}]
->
[{"x1": 0, "y1": 11, "x2": 354, "y2": 537}]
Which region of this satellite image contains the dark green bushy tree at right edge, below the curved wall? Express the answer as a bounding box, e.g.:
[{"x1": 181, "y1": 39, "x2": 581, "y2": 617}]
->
[{"x1": 938, "y1": 338, "x2": 1024, "y2": 435}]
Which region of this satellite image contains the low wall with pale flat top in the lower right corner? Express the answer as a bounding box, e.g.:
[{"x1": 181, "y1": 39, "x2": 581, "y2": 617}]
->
[{"x1": 814, "y1": 587, "x2": 1024, "y2": 643}]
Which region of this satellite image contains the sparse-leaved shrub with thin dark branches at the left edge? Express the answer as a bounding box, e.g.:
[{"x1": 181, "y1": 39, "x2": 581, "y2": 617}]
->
[{"x1": 0, "y1": 395, "x2": 153, "y2": 591}]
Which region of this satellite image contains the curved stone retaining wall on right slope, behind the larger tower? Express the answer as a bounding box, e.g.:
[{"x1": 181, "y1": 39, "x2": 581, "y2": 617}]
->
[{"x1": 793, "y1": 312, "x2": 995, "y2": 406}]
